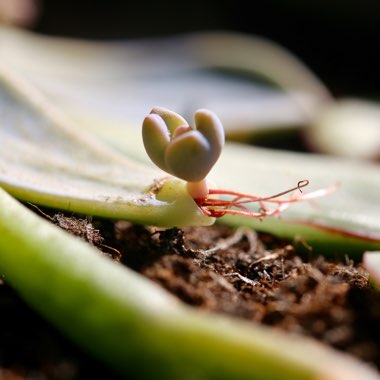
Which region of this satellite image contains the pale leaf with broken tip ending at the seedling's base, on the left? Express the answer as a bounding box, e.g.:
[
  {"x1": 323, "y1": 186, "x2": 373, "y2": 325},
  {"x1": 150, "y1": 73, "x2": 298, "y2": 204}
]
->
[{"x1": 0, "y1": 66, "x2": 213, "y2": 226}]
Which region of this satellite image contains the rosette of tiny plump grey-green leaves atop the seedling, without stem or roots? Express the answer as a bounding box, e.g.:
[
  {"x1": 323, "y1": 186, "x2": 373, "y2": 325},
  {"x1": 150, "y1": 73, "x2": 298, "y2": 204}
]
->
[{"x1": 142, "y1": 107, "x2": 225, "y2": 182}]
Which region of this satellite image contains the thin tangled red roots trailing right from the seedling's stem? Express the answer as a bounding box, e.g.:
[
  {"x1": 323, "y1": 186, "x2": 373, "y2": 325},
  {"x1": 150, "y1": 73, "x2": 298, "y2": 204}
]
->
[{"x1": 195, "y1": 180, "x2": 336, "y2": 219}]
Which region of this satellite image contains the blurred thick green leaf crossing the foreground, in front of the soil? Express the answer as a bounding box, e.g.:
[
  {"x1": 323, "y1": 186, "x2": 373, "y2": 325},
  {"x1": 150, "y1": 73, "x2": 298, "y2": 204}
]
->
[{"x1": 0, "y1": 189, "x2": 379, "y2": 380}]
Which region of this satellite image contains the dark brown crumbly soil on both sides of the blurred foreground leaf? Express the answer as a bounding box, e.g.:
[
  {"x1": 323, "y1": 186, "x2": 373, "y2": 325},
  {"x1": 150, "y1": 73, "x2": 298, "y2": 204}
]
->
[{"x1": 0, "y1": 208, "x2": 380, "y2": 380}]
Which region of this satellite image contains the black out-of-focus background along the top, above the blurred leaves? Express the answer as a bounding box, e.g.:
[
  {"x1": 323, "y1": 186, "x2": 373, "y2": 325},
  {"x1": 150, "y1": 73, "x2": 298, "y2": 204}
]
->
[{"x1": 0, "y1": 0, "x2": 380, "y2": 99}]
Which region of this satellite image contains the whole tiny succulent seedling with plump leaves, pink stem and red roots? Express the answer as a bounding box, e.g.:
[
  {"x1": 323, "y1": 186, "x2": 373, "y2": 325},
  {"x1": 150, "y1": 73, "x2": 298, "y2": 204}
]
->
[{"x1": 142, "y1": 107, "x2": 335, "y2": 218}]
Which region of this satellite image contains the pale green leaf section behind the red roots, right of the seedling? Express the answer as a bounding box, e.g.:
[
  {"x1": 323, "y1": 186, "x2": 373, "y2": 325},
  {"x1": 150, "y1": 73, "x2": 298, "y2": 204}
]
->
[{"x1": 213, "y1": 144, "x2": 380, "y2": 255}]
